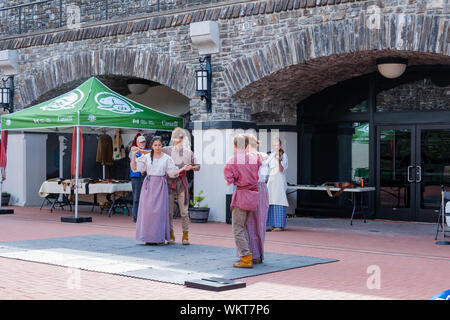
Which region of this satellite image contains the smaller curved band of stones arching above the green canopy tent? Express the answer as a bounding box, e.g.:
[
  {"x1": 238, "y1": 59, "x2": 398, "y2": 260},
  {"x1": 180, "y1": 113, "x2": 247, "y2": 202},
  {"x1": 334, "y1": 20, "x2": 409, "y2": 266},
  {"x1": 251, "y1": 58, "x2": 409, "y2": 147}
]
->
[{"x1": 17, "y1": 48, "x2": 194, "y2": 107}]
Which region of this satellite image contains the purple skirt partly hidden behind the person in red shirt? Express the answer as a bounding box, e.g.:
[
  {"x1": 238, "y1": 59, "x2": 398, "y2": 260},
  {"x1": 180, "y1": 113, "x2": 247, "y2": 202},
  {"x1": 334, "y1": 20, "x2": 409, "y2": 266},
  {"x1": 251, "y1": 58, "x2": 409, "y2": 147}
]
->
[{"x1": 237, "y1": 182, "x2": 269, "y2": 259}]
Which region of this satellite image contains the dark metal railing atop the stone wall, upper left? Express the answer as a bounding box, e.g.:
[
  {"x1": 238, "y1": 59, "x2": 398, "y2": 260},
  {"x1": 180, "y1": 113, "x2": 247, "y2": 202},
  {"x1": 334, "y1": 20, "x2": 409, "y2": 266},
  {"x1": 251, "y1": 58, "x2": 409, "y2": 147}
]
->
[{"x1": 0, "y1": 0, "x2": 185, "y2": 36}]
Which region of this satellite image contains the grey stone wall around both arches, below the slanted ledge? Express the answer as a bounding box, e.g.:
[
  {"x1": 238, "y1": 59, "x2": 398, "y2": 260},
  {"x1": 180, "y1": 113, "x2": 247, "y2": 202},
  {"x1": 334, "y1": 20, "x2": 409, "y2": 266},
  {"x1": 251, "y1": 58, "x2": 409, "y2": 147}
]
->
[{"x1": 0, "y1": 0, "x2": 450, "y2": 124}]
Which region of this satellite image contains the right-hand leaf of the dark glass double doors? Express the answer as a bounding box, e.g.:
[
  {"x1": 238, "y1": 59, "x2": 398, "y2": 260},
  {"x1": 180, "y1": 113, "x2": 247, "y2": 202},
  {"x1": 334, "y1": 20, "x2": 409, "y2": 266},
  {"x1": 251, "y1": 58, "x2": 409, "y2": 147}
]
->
[{"x1": 415, "y1": 125, "x2": 450, "y2": 222}]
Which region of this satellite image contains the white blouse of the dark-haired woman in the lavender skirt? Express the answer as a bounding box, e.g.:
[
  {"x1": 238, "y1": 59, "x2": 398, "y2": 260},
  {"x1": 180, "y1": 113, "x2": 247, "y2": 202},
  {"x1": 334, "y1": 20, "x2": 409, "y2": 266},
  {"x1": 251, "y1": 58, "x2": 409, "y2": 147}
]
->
[{"x1": 136, "y1": 153, "x2": 178, "y2": 178}]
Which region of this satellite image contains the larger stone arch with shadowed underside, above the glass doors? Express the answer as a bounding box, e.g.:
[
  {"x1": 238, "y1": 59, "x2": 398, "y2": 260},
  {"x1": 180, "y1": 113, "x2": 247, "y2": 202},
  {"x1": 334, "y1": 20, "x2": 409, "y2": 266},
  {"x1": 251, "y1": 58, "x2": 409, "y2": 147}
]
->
[{"x1": 224, "y1": 11, "x2": 450, "y2": 107}]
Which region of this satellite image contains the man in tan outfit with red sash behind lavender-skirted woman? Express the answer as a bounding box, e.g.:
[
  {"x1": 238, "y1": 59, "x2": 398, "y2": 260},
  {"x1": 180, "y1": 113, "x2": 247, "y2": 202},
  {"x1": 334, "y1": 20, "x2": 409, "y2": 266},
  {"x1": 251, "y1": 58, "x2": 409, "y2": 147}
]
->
[{"x1": 162, "y1": 128, "x2": 200, "y2": 245}]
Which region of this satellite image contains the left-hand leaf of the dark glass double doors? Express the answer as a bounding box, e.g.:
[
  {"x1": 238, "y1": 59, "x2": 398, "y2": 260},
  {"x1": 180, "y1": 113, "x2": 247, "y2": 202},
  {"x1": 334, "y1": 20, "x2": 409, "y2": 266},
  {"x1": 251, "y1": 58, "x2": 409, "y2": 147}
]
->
[{"x1": 377, "y1": 126, "x2": 415, "y2": 220}]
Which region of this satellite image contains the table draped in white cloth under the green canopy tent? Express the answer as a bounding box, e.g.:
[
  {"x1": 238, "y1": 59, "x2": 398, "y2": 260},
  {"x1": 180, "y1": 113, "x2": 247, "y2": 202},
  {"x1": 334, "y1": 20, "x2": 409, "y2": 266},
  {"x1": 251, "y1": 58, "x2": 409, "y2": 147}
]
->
[{"x1": 39, "y1": 179, "x2": 133, "y2": 216}]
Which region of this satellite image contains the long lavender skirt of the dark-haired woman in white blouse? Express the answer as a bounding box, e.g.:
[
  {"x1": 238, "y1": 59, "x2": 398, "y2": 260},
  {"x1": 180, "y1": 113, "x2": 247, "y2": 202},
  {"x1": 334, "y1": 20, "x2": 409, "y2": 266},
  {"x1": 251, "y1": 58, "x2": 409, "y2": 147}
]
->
[{"x1": 136, "y1": 175, "x2": 170, "y2": 243}]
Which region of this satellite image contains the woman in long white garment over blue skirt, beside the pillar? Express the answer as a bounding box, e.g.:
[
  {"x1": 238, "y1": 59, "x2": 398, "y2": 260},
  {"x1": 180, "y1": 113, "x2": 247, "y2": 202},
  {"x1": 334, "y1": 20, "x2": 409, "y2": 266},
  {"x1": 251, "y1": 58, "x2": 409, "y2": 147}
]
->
[{"x1": 267, "y1": 137, "x2": 289, "y2": 231}]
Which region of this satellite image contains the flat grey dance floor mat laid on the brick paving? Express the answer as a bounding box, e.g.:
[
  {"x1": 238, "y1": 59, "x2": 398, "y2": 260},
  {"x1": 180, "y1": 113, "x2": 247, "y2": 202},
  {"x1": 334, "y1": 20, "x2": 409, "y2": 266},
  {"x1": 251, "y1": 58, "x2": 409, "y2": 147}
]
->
[{"x1": 0, "y1": 234, "x2": 338, "y2": 285}]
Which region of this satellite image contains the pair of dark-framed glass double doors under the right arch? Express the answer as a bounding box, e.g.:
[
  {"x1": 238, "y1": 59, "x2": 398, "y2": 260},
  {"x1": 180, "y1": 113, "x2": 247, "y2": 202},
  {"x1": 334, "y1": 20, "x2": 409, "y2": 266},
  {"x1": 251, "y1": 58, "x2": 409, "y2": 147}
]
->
[{"x1": 377, "y1": 125, "x2": 450, "y2": 222}]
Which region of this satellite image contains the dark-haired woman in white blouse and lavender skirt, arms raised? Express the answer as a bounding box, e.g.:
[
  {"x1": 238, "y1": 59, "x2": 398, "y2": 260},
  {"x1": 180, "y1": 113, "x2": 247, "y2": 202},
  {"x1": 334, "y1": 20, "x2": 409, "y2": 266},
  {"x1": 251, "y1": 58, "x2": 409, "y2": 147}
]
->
[{"x1": 130, "y1": 136, "x2": 185, "y2": 245}]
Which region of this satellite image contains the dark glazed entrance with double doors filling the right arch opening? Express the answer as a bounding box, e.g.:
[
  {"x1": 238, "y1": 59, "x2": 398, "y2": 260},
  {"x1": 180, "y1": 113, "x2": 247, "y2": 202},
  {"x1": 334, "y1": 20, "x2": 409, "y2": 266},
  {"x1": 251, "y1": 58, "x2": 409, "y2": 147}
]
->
[{"x1": 297, "y1": 64, "x2": 450, "y2": 222}]
